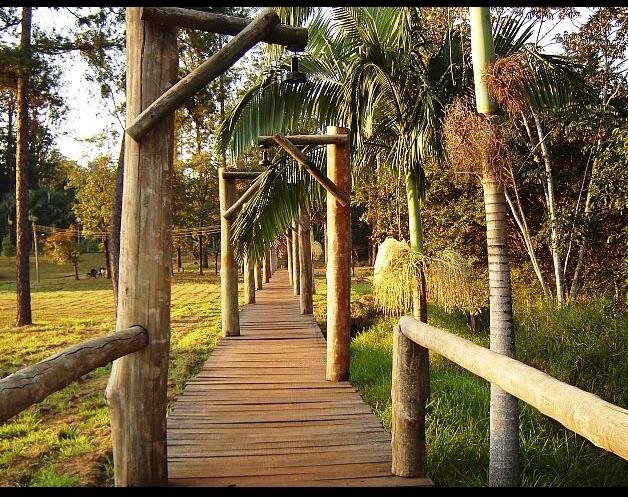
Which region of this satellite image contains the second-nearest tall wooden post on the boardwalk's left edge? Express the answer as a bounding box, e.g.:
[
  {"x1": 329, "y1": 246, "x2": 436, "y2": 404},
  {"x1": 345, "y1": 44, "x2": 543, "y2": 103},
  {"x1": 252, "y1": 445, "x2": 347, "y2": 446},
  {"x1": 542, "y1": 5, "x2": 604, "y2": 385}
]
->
[{"x1": 218, "y1": 167, "x2": 240, "y2": 337}]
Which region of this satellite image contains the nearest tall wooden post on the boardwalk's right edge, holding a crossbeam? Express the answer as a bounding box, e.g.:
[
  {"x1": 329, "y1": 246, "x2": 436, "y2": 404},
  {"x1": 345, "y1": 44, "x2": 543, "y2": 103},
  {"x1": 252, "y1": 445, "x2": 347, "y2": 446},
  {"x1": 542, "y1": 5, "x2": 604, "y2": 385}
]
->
[{"x1": 326, "y1": 126, "x2": 351, "y2": 381}]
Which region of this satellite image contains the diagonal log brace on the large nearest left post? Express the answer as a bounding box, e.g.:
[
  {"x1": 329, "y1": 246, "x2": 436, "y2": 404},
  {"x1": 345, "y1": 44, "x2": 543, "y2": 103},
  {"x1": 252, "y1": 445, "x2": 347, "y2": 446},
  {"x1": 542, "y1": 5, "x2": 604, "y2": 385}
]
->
[{"x1": 126, "y1": 8, "x2": 279, "y2": 141}]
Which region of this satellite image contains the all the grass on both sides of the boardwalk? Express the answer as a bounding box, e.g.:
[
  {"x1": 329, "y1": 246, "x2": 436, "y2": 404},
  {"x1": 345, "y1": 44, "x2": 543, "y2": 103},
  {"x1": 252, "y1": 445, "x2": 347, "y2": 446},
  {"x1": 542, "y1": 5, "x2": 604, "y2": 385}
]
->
[{"x1": 0, "y1": 254, "x2": 628, "y2": 486}]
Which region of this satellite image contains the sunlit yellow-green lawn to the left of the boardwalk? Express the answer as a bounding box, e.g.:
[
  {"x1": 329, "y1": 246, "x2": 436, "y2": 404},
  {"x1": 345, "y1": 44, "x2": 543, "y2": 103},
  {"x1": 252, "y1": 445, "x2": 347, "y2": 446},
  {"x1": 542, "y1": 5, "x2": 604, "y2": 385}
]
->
[{"x1": 0, "y1": 254, "x2": 220, "y2": 486}]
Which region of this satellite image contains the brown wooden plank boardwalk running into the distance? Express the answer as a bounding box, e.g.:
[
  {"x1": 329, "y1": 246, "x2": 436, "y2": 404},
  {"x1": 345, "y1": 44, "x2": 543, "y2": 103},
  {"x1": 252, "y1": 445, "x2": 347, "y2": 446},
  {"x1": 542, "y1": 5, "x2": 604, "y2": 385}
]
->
[{"x1": 168, "y1": 270, "x2": 431, "y2": 486}]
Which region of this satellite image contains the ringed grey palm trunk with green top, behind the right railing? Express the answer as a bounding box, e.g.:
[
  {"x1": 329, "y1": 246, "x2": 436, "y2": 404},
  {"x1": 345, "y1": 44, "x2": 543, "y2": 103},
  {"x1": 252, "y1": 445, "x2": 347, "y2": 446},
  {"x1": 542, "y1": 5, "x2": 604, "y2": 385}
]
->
[{"x1": 469, "y1": 7, "x2": 519, "y2": 486}]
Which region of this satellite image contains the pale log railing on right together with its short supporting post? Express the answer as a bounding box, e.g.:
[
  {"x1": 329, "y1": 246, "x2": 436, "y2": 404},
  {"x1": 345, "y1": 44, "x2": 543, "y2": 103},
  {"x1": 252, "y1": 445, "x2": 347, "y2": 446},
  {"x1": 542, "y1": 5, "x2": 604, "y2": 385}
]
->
[{"x1": 392, "y1": 316, "x2": 628, "y2": 477}]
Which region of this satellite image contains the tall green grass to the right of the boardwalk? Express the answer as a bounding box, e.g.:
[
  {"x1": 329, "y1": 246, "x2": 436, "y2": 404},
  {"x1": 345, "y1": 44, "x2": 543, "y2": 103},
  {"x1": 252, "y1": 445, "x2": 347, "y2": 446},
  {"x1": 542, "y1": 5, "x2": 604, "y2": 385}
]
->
[{"x1": 315, "y1": 268, "x2": 628, "y2": 486}]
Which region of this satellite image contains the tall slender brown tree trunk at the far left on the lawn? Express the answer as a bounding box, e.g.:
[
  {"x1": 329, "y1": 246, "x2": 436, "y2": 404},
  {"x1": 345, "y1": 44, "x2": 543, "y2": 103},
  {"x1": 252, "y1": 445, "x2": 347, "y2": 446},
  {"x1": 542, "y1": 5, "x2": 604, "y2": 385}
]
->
[{"x1": 15, "y1": 7, "x2": 33, "y2": 326}]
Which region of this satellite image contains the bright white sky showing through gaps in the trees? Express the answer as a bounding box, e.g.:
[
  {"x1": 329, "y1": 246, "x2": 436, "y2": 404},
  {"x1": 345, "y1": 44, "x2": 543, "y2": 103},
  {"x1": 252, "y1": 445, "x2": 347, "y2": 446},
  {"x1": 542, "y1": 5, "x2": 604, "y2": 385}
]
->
[{"x1": 28, "y1": 8, "x2": 588, "y2": 165}]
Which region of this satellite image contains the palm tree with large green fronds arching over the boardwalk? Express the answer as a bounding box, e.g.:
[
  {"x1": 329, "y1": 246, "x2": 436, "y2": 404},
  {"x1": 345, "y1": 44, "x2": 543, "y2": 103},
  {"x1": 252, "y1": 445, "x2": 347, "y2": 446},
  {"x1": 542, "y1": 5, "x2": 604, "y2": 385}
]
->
[{"x1": 220, "y1": 8, "x2": 464, "y2": 321}]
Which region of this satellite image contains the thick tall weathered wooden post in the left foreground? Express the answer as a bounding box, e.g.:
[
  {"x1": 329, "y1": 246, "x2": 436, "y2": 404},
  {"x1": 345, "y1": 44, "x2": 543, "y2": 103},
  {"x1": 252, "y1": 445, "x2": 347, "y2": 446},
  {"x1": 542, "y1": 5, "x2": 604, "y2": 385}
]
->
[{"x1": 106, "y1": 7, "x2": 178, "y2": 486}]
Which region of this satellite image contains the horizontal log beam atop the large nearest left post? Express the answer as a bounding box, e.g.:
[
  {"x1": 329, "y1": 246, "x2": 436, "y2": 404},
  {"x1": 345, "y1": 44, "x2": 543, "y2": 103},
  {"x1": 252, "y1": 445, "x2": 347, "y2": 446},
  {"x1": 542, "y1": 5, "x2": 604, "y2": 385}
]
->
[{"x1": 142, "y1": 7, "x2": 307, "y2": 51}]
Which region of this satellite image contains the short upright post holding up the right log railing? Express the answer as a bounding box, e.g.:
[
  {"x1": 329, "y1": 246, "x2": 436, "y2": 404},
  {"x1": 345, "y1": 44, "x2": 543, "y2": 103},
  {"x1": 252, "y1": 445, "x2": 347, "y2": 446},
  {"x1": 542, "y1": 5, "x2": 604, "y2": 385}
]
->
[{"x1": 391, "y1": 325, "x2": 430, "y2": 477}]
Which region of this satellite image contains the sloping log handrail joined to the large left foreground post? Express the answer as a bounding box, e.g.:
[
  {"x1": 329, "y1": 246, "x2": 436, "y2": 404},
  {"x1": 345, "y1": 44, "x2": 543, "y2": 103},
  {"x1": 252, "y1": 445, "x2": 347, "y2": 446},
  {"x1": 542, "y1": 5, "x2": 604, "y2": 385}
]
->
[{"x1": 0, "y1": 326, "x2": 148, "y2": 423}]
